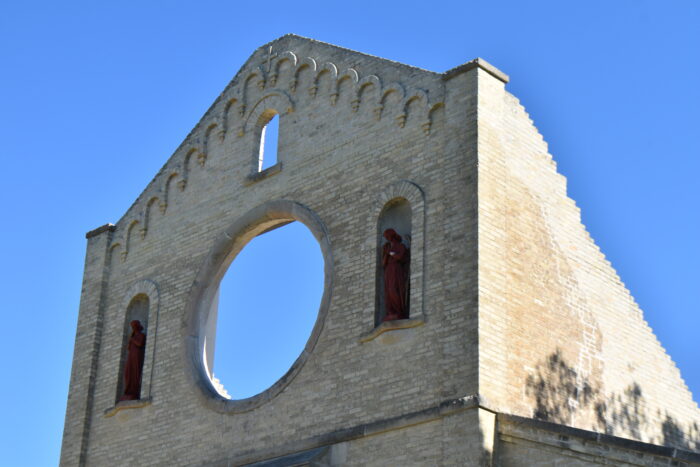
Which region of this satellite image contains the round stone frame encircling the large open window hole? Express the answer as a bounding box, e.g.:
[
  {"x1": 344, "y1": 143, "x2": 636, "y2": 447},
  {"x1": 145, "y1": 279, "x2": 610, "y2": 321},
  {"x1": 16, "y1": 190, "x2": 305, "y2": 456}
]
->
[{"x1": 183, "y1": 200, "x2": 333, "y2": 414}]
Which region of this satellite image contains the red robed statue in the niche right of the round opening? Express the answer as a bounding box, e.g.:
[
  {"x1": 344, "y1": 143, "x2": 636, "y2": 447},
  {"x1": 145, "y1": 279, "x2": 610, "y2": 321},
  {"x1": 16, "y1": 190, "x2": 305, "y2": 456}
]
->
[{"x1": 382, "y1": 229, "x2": 409, "y2": 321}]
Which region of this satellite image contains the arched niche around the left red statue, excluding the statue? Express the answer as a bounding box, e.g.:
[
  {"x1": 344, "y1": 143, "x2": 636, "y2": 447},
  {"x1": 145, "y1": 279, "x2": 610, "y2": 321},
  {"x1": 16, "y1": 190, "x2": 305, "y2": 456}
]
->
[{"x1": 115, "y1": 279, "x2": 160, "y2": 401}]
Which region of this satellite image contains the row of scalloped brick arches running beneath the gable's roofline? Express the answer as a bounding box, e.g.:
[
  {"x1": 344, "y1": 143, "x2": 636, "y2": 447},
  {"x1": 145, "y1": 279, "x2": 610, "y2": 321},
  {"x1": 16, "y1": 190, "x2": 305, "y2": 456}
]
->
[{"x1": 105, "y1": 50, "x2": 444, "y2": 261}]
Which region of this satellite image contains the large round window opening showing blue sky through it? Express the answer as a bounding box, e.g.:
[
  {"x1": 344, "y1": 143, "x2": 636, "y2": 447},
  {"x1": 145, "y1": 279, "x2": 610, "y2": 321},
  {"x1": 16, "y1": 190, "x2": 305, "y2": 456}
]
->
[{"x1": 202, "y1": 222, "x2": 324, "y2": 400}]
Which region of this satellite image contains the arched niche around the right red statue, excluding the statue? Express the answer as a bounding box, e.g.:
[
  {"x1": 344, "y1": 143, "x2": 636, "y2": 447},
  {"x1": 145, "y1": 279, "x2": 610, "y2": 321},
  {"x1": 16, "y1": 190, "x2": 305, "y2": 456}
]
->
[{"x1": 361, "y1": 180, "x2": 426, "y2": 342}]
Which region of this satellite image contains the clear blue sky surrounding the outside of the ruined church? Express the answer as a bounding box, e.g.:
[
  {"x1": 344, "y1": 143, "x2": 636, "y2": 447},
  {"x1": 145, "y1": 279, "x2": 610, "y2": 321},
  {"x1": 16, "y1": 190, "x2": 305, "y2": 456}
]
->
[{"x1": 0, "y1": 0, "x2": 700, "y2": 465}]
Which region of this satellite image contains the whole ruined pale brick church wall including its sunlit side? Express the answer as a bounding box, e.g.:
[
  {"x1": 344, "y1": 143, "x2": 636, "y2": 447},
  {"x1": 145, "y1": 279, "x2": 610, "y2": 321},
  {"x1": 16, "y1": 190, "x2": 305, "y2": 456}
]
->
[{"x1": 61, "y1": 35, "x2": 700, "y2": 466}]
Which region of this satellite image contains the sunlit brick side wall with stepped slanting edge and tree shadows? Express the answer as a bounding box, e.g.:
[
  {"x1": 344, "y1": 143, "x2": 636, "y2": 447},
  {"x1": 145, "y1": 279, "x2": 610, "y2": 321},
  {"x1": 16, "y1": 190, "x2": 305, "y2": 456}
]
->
[{"x1": 479, "y1": 77, "x2": 700, "y2": 449}]
